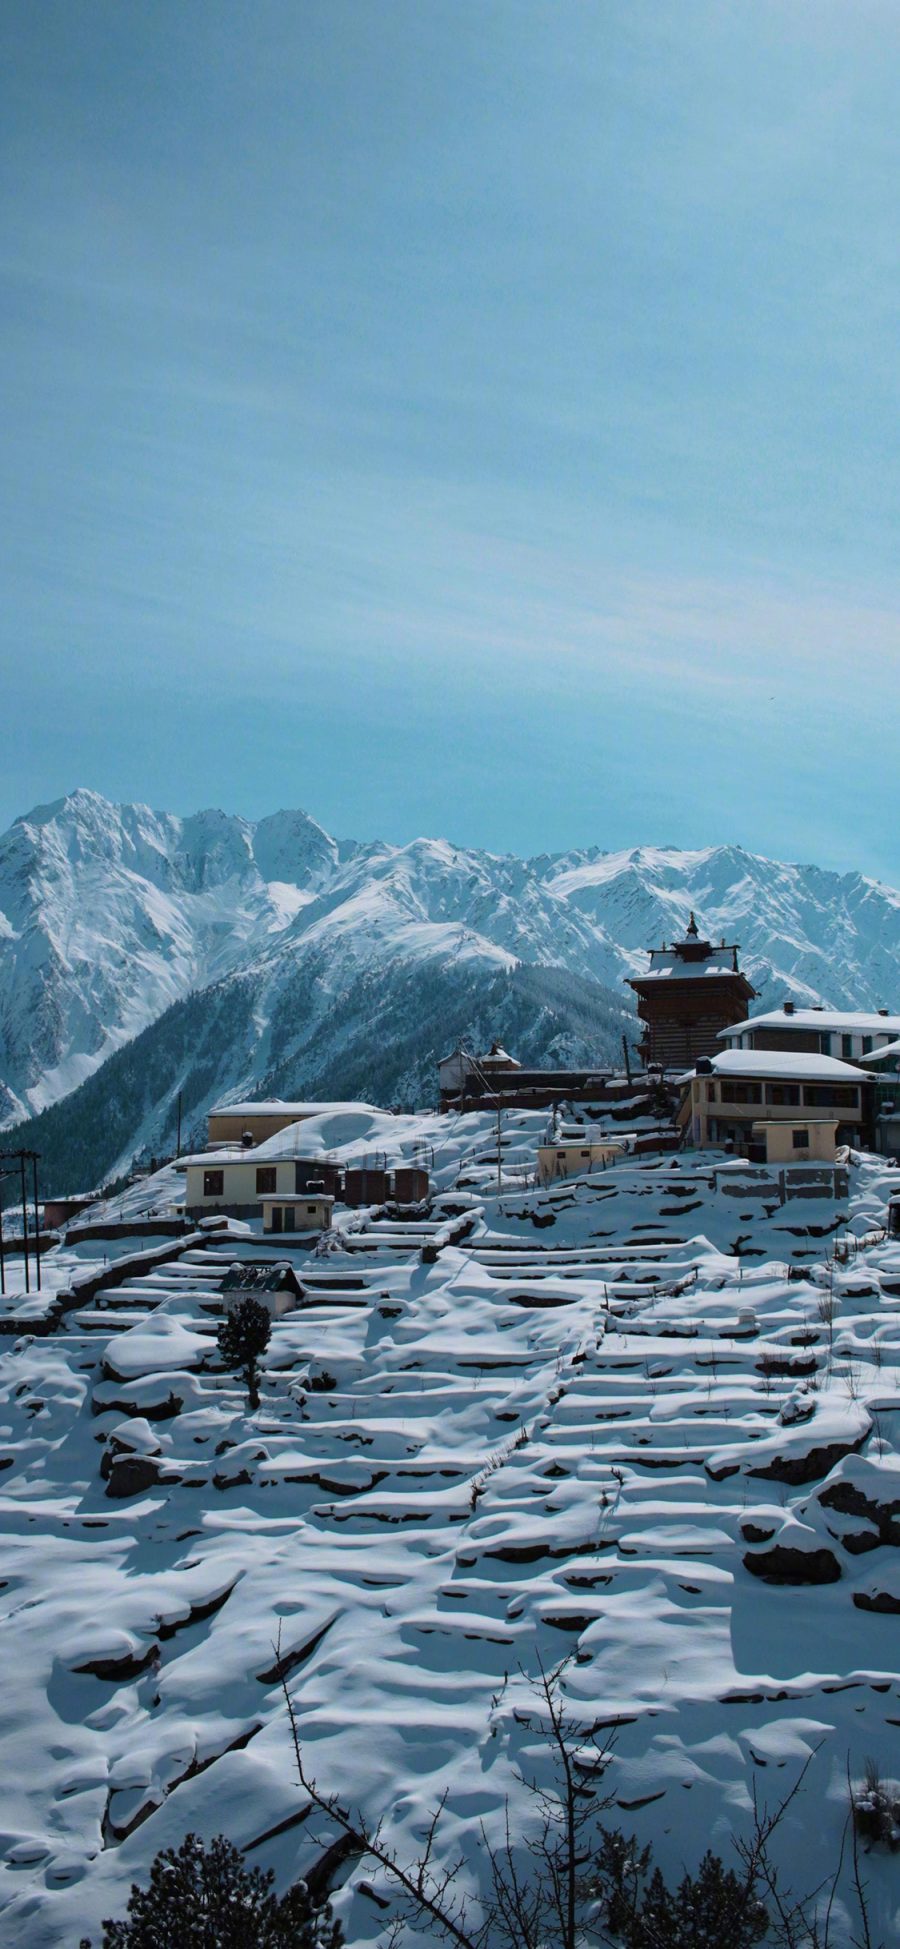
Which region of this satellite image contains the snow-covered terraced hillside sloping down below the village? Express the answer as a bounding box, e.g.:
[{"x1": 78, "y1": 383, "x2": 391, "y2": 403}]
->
[{"x1": 0, "y1": 1113, "x2": 900, "y2": 1949}]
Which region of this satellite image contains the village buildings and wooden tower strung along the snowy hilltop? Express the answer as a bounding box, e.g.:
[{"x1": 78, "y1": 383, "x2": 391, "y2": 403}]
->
[{"x1": 0, "y1": 912, "x2": 900, "y2": 1294}]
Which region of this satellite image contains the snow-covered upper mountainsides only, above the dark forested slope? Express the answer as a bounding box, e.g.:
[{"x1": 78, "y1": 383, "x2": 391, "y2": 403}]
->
[{"x1": 0, "y1": 791, "x2": 900, "y2": 1123}]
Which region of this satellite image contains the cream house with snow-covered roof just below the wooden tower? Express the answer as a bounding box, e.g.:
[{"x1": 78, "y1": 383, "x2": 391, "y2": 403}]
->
[{"x1": 676, "y1": 1049, "x2": 873, "y2": 1156}]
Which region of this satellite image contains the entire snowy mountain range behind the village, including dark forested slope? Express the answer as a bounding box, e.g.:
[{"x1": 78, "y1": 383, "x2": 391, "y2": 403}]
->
[{"x1": 0, "y1": 789, "x2": 900, "y2": 1189}]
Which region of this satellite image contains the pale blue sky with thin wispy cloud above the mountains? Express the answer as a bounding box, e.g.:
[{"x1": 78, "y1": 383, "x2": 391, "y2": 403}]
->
[{"x1": 0, "y1": 0, "x2": 900, "y2": 885}]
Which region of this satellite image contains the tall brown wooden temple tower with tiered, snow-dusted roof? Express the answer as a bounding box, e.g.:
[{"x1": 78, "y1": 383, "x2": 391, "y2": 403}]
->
[{"x1": 627, "y1": 914, "x2": 756, "y2": 1070}]
